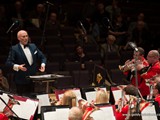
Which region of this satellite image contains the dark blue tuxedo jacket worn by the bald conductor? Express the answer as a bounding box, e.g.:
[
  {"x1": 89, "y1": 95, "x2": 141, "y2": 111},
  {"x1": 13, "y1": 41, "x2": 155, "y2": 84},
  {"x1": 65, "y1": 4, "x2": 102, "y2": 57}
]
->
[{"x1": 6, "y1": 43, "x2": 46, "y2": 84}]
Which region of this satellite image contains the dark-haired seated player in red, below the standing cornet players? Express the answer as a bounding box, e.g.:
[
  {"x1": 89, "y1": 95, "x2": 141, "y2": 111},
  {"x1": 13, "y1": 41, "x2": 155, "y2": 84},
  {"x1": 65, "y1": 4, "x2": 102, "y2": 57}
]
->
[{"x1": 115, "y1": 85, "x2": 149, "y2": 120}]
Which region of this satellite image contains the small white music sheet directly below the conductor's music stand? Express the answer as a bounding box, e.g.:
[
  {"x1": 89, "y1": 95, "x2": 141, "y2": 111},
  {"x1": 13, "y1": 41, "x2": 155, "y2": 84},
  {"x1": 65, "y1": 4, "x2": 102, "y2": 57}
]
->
[{"x1": 37, "y1": 94, "x2": 51, "y2": 114}]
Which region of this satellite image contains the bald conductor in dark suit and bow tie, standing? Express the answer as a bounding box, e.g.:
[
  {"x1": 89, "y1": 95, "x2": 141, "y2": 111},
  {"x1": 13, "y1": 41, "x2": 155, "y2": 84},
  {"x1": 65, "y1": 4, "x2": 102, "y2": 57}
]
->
[{"x1": 6, "y1": 30, "x2": 47, "y2": 95}]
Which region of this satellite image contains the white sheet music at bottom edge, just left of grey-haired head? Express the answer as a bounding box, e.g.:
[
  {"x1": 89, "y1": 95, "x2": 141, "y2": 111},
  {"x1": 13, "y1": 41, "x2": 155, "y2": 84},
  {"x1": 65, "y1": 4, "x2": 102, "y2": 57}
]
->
[{"x1": 44, "y1": 108, "x2": 69, "y2": 120}]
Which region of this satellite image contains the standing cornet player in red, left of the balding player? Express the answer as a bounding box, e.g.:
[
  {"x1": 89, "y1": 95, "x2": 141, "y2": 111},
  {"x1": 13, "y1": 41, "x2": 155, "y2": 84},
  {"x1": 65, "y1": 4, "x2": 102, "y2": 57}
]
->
[{"x1": 119, "y1": 47, "x2": 149, "y2": 98}]
